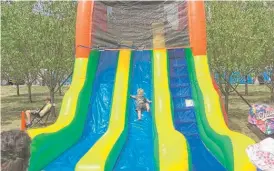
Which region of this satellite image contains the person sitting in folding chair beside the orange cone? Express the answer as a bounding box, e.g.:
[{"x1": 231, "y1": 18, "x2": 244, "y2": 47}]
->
[{"x1": 25, "y1": 97, "x2": 52, "y2": 127}]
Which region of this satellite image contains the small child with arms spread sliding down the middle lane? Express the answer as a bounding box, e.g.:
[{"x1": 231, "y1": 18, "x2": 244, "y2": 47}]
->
[{"x1": 130, "y1": 88, "x2": 151, "y2": 120}]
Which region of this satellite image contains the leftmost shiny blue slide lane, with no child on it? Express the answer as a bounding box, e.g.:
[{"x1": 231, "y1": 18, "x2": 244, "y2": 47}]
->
[{"x1": 44, "y1": 51, "x2": 118, "y2": 171}]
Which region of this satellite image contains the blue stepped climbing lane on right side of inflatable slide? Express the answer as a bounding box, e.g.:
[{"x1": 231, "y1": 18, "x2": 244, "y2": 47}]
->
[{"x1": 168, "y1": 49, "x2": 226, "y2": 171}]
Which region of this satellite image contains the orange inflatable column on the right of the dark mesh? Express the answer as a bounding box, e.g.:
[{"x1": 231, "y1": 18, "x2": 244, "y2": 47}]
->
[{"x1": 187, "y1": 0, "x2": 206, "y2": 56}]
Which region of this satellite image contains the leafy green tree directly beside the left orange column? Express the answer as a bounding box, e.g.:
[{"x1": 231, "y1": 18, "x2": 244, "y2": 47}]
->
[{"x1": 34, "y1": 1, "x2": 76, "y2": 111}]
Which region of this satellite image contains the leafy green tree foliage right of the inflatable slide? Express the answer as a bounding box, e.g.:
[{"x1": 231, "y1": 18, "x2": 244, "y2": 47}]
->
[{"x1": 206, "y1": 1, "x2": 274, "y2": 110}]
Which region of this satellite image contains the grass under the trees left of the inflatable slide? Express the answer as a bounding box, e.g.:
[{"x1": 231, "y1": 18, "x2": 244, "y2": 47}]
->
[{"x1": 1, "y1": 85, "x2": 67, "y2": 131}]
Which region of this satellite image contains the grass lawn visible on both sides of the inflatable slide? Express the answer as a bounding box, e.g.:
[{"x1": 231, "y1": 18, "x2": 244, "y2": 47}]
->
[{"x1": 1, "y1": 85, "x2": 270, "y2": 141}]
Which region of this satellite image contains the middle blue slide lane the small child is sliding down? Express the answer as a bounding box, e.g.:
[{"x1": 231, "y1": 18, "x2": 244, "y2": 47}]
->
[{"x1": 113, "y1": 51, "x2": 155, "y2": 171}]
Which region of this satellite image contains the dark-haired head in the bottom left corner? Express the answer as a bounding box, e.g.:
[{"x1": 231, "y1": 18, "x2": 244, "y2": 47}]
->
[{"x1": 1, "y1": 130, "x2": 31, "y2": 171}]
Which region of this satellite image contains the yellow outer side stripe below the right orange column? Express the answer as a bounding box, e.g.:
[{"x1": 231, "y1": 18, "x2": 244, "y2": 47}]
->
[{"x1": 194, "y1": 56, "x2": 256, "y2": 171}]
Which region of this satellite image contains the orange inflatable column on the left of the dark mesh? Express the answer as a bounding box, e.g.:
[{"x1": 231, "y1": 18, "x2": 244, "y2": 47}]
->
[{"x1": 75, "y1": 1, "x2": 94, "y2": 58}]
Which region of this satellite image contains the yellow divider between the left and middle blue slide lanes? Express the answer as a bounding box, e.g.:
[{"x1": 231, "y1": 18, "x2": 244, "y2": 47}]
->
[{"x1": 75, "y1": 50, "x2": 131, "y2": 171}]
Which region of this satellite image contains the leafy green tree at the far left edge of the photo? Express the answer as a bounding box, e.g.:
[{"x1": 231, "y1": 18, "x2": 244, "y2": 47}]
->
[{"x1": 1, "y1": 2, "x2": 39, "y2": 97}]
